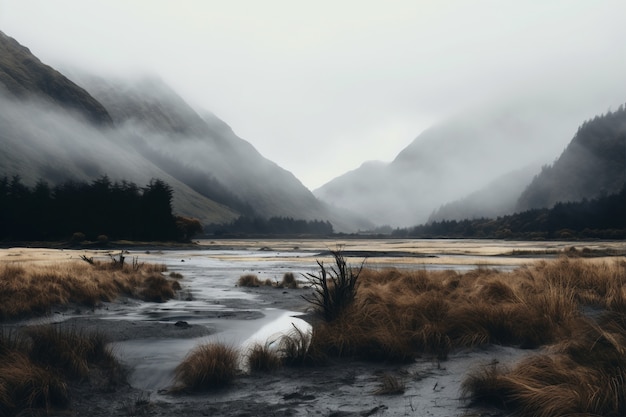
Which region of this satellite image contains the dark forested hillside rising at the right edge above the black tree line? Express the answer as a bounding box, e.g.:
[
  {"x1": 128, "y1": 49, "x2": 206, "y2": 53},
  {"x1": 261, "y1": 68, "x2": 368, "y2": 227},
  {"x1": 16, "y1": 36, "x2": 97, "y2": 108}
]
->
[{"x1": 516, "y1": 105, "x2": 626, "y2": 210}]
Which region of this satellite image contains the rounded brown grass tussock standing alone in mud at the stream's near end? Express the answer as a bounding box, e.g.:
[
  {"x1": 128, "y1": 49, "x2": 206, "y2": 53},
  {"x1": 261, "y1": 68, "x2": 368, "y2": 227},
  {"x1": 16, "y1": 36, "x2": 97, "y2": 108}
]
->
[{"x1": 174, "y1": 343, "x2": 239, "y2": 391}]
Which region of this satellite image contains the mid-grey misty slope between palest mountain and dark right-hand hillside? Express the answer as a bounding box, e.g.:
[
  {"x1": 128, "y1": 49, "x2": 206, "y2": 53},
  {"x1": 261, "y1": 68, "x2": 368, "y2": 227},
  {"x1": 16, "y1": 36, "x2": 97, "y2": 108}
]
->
[{"x1": 428, "y1": 164, "x2": 541, "y2": 223}]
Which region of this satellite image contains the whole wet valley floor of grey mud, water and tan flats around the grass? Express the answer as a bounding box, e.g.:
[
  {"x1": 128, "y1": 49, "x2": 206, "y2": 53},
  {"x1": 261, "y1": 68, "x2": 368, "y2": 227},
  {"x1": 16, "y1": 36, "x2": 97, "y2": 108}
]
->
[{"x1": 0, "y1": 240, "x2": 626, "y2": 416}]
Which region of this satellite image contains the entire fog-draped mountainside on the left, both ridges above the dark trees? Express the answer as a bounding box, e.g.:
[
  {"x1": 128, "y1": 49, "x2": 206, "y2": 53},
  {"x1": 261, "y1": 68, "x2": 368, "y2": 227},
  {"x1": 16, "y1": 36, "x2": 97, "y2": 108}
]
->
[{"x1": 0, "y1": 33, "x2": 368, "y2": 231}]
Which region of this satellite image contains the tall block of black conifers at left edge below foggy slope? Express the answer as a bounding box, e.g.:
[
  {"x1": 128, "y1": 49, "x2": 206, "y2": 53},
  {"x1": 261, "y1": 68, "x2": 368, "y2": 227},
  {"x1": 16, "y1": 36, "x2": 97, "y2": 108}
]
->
[{"x1": 0, "y1": 176, "x2": 197, "y2": 241}]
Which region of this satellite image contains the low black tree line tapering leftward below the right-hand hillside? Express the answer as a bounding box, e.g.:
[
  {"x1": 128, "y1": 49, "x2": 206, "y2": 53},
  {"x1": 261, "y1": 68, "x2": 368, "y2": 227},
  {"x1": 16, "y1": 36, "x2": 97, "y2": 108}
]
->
[{"x1": 391, "y1": 186, "x2": 626, "y2": 239}]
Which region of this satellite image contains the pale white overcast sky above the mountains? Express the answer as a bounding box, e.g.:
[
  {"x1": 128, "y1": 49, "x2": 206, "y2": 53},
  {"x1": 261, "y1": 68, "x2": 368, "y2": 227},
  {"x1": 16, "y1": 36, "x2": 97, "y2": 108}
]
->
[{"x1": 0, "y1": 0, "x2": 626, "y2": 189}]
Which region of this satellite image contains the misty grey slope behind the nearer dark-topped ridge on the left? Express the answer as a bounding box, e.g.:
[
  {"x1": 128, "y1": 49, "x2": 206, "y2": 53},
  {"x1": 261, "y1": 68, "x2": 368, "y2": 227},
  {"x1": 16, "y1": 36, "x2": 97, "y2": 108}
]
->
[{"x1": 72, "y1": 72, "x2": 368, "y2": 230}]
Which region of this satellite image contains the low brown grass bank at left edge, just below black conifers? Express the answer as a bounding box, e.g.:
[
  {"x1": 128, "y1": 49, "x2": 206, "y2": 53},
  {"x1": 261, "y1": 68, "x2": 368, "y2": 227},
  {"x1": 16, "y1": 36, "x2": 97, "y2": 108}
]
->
[{"x1": 0, "y1": 261, "x2": 180, "y2": 319}]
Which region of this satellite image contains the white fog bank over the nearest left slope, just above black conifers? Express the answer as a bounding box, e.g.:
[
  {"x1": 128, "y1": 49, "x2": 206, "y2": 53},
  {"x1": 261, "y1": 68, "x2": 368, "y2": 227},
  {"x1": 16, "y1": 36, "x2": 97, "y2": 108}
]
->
[{"x1": 0, "y1": 96, "x2": 241, "y2": 222}]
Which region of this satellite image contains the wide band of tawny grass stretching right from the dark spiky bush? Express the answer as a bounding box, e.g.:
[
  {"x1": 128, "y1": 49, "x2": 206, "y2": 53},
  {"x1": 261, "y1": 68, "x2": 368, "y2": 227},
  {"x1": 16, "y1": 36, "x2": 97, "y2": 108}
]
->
[{"x1": 304, "y1": 258, "x2": 626, "y2": 361}]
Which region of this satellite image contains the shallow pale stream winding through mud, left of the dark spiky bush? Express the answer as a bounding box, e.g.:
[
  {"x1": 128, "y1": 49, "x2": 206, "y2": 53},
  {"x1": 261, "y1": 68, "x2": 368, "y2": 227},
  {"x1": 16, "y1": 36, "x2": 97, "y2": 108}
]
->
[{"x1": 109, "y1": 250, "x2": 315, "y2": 391}]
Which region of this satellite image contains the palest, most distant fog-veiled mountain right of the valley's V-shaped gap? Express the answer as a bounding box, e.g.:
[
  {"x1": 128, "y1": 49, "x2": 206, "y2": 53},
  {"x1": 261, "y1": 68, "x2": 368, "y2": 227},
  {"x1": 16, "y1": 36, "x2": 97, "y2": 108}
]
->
[{"x1": 314, "y1": 104, "x2": 571, "y2": 227}]
